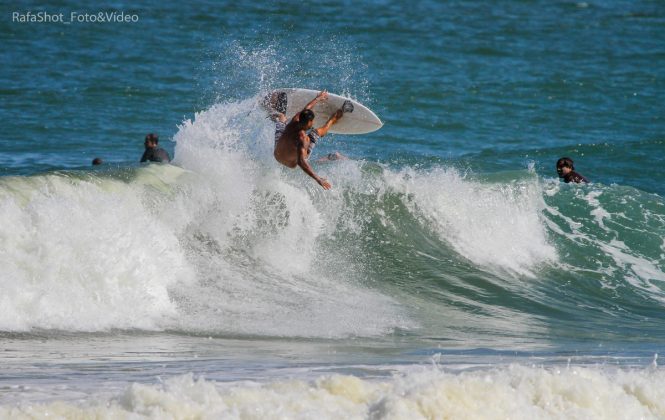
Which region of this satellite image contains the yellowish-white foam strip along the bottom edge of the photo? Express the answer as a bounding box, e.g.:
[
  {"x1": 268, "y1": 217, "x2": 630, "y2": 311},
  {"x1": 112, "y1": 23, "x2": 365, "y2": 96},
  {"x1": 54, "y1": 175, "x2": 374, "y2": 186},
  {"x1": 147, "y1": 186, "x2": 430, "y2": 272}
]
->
[{"x1": 0, "y1": 366, "x2": 665, "y2": 419}]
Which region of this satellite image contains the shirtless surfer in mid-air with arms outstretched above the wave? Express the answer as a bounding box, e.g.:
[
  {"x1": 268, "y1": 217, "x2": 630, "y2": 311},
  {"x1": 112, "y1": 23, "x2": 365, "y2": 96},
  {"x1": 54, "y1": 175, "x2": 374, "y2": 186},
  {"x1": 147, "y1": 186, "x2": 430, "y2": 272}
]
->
[{"x1": 271, "y1": 90, "x2": 344, "y2": 190}]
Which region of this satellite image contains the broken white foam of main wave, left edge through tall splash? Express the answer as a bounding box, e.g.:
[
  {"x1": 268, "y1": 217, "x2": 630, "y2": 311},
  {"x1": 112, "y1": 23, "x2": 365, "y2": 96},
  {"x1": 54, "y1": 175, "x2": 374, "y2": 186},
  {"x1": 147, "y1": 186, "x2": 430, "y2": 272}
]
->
[{"x1": 0, "y1": 98, "x2": 413, "y2": 337}]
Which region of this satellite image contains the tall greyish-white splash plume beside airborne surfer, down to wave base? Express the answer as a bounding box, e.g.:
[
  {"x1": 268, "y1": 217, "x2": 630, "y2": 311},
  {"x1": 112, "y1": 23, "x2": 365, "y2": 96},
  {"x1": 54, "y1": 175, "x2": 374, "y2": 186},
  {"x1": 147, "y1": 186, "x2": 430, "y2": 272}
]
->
[{"x1": 165, "y1": 98, "x2": 413, "y2": 337}]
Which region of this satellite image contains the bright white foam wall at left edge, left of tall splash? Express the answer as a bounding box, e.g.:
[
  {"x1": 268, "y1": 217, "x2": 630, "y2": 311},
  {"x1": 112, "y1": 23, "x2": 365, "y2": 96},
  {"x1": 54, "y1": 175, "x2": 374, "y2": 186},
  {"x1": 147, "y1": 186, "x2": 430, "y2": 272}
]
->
[{"x1": 0, "y1": 170, "x2": 192, "y2": 331}]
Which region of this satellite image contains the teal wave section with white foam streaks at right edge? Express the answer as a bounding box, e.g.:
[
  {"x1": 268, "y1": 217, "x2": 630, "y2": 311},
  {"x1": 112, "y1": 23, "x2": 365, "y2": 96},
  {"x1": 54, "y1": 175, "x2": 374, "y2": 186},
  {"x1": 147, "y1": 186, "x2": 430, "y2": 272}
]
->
[{"x1": 546, "y1": 180, "x2": 665, "y2": 304}]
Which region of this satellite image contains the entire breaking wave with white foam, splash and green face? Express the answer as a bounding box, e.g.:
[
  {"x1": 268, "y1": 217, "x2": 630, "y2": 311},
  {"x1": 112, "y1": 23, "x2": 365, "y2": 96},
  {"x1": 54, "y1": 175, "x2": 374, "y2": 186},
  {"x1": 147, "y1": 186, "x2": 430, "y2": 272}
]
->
[{"x1": 0, "y1": 97, "x2": 665, "y2": 345}]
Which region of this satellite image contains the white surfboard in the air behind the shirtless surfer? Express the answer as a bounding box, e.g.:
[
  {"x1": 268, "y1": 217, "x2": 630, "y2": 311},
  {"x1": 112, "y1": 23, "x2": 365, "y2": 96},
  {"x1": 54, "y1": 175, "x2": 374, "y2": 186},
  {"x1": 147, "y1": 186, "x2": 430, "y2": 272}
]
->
[{"x1": 264, "y1": 88, "x2": 383, "y2": 134}]
